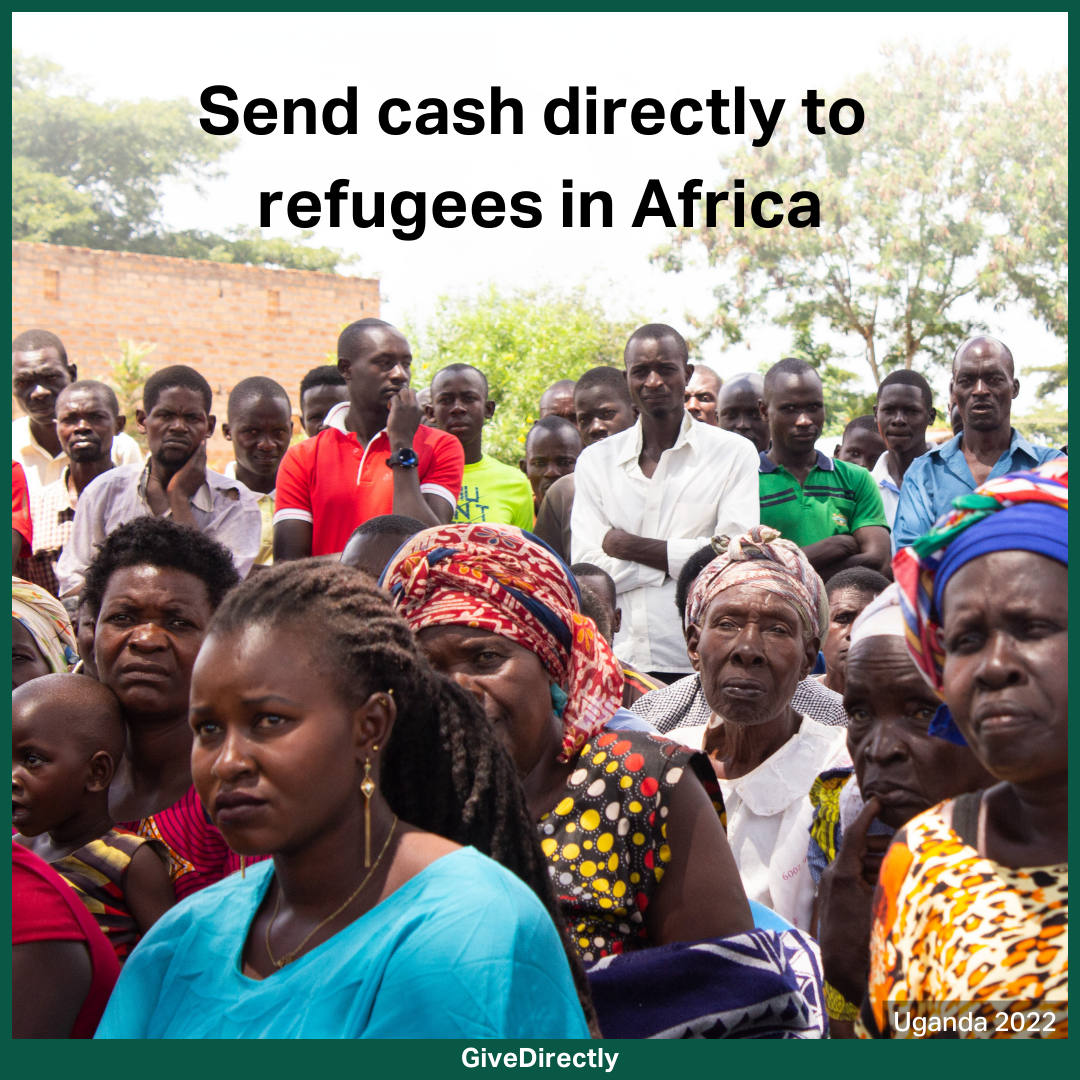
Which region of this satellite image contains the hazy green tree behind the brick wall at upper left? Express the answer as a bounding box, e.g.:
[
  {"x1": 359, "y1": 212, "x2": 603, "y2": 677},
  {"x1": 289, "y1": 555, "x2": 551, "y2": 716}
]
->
[{"x1": 11, "y1": 50, "x2": 355, "y2": 272}]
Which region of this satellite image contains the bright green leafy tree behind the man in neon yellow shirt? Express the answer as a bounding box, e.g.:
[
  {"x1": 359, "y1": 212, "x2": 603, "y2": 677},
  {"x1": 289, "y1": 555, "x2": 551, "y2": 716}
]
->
[{"x1": 403, "y1": 285, "x2": 644, "y2": 465}]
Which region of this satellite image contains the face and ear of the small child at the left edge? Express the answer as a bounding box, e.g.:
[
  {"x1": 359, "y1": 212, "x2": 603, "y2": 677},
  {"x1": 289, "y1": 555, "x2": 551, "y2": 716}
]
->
[{"x1": 11, "y1": 702, "x2": 112, "y2": 836}]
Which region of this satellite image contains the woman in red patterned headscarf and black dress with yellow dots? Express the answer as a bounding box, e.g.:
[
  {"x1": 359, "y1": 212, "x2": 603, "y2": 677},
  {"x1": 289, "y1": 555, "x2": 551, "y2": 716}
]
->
[{"x1": 381, "y1": 525, "x2": 825, "y2": 1037}]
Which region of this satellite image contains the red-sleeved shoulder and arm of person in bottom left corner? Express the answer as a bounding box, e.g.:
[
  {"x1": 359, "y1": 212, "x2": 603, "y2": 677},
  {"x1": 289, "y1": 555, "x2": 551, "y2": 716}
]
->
[{"x1": 11, "y1": 843, "x2": 120, "y2": 1039}]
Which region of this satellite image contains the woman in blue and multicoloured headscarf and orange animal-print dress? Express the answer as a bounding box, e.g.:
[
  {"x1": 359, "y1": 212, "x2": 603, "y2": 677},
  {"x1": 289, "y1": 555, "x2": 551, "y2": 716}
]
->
[{"x1": 858, "y1": 458, "x2": 1068, "y2": 1038}]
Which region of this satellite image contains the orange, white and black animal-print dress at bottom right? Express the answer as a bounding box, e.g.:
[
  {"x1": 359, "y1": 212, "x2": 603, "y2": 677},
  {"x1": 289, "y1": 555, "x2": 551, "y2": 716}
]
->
[{"x1": 855, "y1": 792, "x2": 1069, "y2": 1038}]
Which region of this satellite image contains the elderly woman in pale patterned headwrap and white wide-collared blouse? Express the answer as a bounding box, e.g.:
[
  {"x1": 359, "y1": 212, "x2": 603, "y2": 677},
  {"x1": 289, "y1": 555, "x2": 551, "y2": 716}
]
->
[{"x1": 687, "y1": 525, "x2": 850, "y2": 930}]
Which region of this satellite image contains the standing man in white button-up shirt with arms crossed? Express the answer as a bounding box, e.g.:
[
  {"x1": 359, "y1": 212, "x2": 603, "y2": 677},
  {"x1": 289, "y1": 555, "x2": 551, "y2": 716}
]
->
[{"x1": 570, "y1": 324, "x2": 759, "y2": 681}]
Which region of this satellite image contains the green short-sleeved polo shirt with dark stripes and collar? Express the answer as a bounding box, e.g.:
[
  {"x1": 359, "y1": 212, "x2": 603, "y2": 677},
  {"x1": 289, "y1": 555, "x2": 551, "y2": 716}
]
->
[{"x1": 759, "y1": 450, "x2": 889, "y2": 548}]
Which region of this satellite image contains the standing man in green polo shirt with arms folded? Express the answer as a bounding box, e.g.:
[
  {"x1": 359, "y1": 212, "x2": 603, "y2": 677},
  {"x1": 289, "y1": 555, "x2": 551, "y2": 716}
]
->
[{"x1": 759, "y1": 359, "x2": 890, "y2": 581}]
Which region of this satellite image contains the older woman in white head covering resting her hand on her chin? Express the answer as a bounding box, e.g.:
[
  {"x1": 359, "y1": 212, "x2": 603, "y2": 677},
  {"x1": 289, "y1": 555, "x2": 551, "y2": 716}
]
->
[{"x1": 809, "y1": 583, "x2": 994, "y2": 1039}]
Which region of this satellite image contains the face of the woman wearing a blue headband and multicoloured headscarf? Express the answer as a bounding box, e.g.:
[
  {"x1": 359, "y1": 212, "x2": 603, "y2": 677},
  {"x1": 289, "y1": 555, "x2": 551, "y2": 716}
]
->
[{"x1": 942, "y1": 551, "x2": 1069, "y2": 784}]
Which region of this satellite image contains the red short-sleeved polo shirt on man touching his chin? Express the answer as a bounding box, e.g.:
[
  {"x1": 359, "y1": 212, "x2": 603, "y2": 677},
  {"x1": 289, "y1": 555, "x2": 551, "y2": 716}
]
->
[{"x1": 273, "y1": 402, "x2": 465, "y2": 555}]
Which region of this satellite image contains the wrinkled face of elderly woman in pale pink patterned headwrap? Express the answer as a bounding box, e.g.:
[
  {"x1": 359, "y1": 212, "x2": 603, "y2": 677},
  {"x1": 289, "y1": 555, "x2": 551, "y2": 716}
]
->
[{"x1": 689, "y1": 584, "x2": 819, "y2": 727}]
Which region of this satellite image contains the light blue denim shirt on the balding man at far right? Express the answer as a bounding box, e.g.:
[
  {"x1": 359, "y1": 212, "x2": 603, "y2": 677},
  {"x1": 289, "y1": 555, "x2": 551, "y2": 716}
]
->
[{"x1": 892, "y1": 428, "x2": 1062, "y2": 551}]
